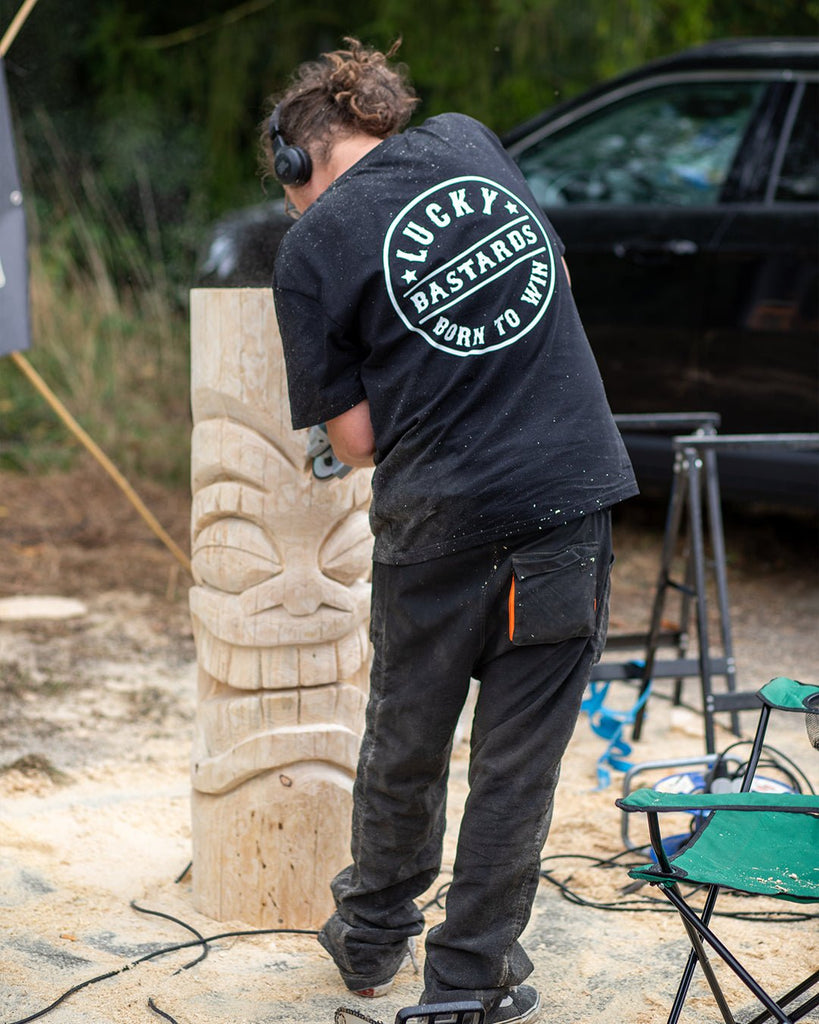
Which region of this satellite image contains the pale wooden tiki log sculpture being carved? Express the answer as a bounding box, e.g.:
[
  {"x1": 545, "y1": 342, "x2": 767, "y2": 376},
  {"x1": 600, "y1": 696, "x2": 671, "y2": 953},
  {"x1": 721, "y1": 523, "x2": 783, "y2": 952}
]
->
[{"x1": 190, "y1": 289, "x2": 372, "y2": 929}]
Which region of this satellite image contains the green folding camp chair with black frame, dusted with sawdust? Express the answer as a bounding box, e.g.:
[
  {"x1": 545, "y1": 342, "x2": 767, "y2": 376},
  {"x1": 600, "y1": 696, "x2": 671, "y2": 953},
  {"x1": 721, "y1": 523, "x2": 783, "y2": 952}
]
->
[{"x1": 616, "y1": 677, "x2": 819, "y2": 1024}]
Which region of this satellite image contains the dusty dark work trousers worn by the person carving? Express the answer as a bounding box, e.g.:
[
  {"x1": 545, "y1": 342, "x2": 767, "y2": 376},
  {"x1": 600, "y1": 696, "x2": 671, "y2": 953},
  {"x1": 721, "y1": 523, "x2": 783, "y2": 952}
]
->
[{"x1": 319, "y1": 510, "x2": 612, "y2": 1005}]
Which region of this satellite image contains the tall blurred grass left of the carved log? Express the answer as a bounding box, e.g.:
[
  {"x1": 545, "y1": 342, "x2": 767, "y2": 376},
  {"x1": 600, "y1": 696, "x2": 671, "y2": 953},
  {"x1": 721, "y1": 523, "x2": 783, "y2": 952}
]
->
[{"x1": 0, "y1": 224, "x2": 190, "y2": 486}]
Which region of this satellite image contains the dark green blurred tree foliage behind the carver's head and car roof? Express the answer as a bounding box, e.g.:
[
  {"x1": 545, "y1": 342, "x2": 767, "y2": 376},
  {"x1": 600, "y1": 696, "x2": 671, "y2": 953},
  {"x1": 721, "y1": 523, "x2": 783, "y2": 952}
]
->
[{"x1": 0, "y1": 0, "x2": 819, "y2": 284}]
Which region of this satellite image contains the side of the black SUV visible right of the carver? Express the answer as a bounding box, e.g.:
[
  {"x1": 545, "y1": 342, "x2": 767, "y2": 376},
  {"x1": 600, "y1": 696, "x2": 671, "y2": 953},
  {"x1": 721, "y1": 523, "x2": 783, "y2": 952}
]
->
[{"x1": 504, "y1": 38, "x2": 819, "y2": 506}]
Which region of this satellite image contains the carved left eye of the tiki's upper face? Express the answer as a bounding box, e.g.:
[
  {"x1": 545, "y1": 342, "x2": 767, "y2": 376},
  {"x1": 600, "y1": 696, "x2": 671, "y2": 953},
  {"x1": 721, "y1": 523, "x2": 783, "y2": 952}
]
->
[{"x1": 192, "y1": 518, "x2": 282, "y2": 594}]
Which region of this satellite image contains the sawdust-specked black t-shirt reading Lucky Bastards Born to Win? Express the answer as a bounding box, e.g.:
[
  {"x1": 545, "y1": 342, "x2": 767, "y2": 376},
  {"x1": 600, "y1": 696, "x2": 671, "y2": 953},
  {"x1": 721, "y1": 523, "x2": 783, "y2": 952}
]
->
[{"x1": 273, "y1": 114, "x2": 637, "y2": 563}]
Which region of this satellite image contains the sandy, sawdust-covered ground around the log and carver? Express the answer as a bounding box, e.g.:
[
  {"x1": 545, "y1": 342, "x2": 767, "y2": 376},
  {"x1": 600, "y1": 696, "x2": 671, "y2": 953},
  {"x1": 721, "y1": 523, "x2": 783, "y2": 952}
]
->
[{"x1": 0, "y1": 468, "x2": 819, "y2": 1024}]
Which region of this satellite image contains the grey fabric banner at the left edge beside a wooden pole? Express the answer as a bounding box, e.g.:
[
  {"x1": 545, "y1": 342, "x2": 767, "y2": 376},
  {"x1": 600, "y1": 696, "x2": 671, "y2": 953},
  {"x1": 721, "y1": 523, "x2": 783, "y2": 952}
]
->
[{"x1": 0, "y1": 59, "x2": 30, "y2": 355}]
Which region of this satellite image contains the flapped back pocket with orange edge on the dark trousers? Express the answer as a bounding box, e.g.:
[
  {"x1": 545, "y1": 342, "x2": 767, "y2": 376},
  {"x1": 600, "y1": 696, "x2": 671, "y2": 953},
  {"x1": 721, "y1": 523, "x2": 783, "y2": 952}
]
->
[{"x1": 509, "y1": 544, "x2": 597, "y2": 645}]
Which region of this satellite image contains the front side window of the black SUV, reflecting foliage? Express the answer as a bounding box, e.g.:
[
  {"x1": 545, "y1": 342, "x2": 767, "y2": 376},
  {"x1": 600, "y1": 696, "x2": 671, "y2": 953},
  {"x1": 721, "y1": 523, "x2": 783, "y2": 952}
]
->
[{"x1": 517, "y1": 82, "x2": 765, "y2": 207}]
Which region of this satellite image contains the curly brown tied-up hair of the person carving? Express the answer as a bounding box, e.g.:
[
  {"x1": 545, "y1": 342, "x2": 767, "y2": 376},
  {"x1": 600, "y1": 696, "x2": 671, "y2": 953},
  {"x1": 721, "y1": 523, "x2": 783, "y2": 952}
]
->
[{"x1": 261, "y1": 37, "x2": 418, "y2": 169}]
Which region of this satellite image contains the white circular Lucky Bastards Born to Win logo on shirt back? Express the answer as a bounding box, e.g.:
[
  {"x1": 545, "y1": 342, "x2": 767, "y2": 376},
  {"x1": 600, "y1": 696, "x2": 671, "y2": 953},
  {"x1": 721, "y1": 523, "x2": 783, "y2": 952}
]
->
[{"x1": 384, "y1": 176, "x2": 555, "y2": 355}]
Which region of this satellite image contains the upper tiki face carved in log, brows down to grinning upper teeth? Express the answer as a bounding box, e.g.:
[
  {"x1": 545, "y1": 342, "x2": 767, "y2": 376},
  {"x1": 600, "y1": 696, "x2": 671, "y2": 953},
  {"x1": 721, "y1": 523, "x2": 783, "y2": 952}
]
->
[{"x1": 190, "y1": 420, "x2": 372, "y2": 689}]
